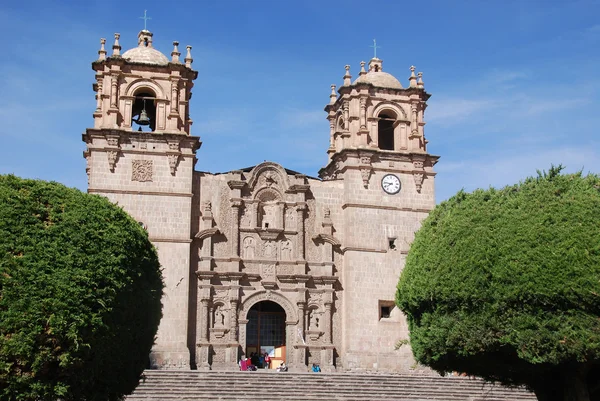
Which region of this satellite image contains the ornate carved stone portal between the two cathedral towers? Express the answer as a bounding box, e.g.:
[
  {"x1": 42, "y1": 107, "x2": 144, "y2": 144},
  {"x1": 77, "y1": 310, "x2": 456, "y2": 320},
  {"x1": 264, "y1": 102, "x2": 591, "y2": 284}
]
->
[{"x1": 196, "y1": 163, "x2": 337, "y2": 371}]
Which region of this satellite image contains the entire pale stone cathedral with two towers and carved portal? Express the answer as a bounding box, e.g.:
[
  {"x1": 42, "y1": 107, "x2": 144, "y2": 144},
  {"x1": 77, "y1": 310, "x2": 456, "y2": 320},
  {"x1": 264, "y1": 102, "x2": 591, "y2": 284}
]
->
[{"x1": 83, "y1": 30, "x2": 438, "y2": 371}]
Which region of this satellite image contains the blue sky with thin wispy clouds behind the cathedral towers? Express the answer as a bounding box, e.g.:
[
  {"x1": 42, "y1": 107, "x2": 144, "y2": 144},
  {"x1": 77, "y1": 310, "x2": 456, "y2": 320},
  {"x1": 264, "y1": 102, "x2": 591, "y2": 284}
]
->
[{"x1": 0, "y1": 0, "x2": 600, "y2": 201}]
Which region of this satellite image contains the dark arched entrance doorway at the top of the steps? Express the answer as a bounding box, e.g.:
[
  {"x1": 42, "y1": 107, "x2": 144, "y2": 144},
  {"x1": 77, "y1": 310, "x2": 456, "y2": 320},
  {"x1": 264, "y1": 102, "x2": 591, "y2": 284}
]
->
[{"x1": 245, "y1": 301, "x2": 286, "y2": 367}]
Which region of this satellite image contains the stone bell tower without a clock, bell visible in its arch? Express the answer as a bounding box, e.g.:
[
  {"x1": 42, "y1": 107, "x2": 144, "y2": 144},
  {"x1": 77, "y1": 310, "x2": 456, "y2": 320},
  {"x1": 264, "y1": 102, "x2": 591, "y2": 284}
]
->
[{"x1": 83, "y1": 29, "x2": 201, "y2": 369}]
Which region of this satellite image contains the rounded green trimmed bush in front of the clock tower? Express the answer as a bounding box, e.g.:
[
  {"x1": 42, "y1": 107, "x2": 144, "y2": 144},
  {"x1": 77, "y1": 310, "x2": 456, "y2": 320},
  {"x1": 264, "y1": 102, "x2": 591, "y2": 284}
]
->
[{"x1": 396, "y1": 166, "x2": 600, "y2": 400}]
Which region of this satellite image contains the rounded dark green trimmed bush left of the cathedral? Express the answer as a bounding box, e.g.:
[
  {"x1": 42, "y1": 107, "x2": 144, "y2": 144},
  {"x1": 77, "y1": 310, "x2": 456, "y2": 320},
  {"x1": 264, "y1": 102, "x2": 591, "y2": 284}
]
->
[{"x1": 0, "y1": 176, "x2": 163, "y2": 401}]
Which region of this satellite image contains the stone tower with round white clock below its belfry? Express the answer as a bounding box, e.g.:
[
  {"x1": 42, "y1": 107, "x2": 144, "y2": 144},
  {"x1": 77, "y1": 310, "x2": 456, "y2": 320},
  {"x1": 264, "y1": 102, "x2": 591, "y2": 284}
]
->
[{"x1": 319, "y1": 57, "x2": 439, "y2": 369}]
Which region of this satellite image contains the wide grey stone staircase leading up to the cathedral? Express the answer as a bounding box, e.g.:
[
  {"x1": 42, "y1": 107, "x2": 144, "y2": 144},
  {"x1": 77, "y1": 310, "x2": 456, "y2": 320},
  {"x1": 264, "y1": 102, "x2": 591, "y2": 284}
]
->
[{"x1": 126, "y1": 370, "x2": 536, "y2": 401}]
